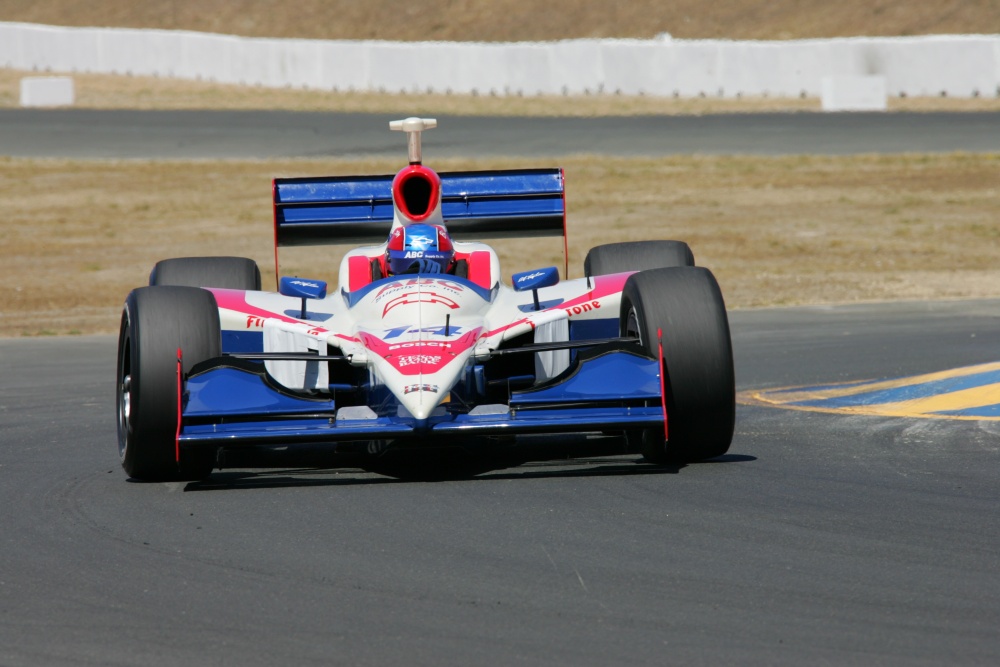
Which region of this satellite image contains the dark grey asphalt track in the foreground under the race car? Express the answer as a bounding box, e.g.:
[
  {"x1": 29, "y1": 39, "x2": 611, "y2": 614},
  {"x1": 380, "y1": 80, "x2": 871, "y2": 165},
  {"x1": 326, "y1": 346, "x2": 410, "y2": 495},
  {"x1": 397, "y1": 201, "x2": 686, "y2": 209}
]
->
[{"x1": 0, "y1": 300, "x2": 1000, "y2": 666}]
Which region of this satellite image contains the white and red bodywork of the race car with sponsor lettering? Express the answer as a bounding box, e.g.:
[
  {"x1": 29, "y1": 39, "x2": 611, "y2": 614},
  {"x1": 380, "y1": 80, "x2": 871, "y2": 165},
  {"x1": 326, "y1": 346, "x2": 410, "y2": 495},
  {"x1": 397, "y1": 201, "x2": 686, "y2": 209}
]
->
[{"x1": 212, "y1": 118, "x2": 627, "y2": 419}]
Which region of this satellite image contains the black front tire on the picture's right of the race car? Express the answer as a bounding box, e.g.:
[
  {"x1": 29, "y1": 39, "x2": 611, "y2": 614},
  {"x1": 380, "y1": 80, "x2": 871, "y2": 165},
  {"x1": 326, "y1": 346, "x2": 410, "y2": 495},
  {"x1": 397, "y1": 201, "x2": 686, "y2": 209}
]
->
[{"x1": 620, "y1": 267, "x2": 736, "y2": 463}]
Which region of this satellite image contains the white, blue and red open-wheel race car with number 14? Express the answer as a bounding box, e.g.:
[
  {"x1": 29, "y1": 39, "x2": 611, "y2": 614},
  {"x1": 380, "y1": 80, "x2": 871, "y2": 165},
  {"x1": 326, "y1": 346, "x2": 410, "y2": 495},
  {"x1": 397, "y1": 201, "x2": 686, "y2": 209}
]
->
[{"x1": 116, "y1": 118, "x2": 735, "y2": 480}]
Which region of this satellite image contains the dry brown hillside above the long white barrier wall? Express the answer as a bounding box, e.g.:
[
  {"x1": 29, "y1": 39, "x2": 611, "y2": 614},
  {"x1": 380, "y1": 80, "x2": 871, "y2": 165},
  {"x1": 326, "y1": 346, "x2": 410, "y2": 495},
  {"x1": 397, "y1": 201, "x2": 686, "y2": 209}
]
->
[{"x1": 0, "y1": 0, "x2": 1000, "y2": 41}]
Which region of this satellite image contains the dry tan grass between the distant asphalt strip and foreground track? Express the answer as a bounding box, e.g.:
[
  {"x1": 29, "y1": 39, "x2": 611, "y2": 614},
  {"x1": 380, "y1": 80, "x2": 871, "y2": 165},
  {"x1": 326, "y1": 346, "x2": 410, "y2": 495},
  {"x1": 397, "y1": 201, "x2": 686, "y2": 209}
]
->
[{"x1": 0, "y1": 154, "x2": 1000, "y2": 336}]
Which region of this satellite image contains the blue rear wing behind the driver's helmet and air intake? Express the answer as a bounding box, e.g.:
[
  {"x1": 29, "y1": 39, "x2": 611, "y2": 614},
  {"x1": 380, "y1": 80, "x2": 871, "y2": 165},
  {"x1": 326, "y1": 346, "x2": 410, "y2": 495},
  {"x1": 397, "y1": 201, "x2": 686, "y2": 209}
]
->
[{"x1": 273, "y1": 169, "x2": 566, "y2": 246}]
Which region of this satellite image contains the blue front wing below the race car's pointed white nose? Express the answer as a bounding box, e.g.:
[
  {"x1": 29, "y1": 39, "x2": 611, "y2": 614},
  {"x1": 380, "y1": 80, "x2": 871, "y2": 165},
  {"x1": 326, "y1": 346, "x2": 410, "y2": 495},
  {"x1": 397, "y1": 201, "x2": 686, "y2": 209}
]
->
[{"x1": 177, "y1": 345, "x2": 666, "y2": 455}]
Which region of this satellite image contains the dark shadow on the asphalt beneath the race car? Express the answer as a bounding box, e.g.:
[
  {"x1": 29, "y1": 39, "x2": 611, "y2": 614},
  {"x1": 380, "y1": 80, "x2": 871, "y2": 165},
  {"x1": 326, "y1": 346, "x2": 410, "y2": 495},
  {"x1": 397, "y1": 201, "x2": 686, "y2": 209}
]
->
[{"x1": 184, "y1": 454, "x2": 757, "y2": 491}]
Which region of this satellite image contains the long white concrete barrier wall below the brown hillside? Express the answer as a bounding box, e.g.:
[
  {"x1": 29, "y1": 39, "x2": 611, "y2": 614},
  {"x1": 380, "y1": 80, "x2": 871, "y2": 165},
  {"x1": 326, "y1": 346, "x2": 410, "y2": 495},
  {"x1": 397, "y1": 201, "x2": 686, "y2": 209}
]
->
[{"x1": 0, "y1": 23, "x2": 1000, "y2": 97}]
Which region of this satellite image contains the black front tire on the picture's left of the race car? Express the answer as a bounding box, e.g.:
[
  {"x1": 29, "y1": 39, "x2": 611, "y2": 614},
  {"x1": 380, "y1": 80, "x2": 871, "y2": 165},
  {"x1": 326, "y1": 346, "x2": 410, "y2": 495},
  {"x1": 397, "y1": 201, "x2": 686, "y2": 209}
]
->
[{"x1": 116, "y1": 286, "x2": 222, "y2": 481}]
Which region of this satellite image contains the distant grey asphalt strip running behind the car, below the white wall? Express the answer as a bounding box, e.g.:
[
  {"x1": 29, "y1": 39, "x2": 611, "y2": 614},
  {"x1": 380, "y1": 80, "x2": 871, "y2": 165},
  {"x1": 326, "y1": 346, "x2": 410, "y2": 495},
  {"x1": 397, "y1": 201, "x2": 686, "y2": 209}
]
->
[{"x1": 0, "y1": 109, "x2": 1000, "y2": 160}]
